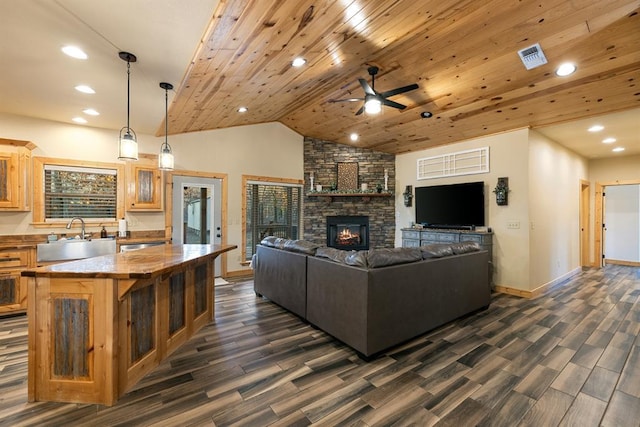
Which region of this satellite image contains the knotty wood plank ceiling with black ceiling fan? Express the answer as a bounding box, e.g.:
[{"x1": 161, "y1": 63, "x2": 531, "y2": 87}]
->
[{"x1": 169, "y1": 0, "x2": 640, "y2": 154}]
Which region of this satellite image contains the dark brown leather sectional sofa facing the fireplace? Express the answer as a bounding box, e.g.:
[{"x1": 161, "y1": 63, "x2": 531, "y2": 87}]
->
[{"x1": 253, "y1": 238, "x2": 491, "y2": 358}]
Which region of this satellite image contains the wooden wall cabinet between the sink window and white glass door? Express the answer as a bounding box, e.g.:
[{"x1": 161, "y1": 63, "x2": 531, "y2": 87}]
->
[{"x1": 126, "y1": 154, "x2": 162, "y2": 211}]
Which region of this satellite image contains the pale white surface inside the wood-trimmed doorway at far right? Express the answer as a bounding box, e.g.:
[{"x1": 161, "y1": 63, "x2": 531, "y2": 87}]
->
[{"x1": 604, "y1": 185, "x2": 640, "y2": 262}]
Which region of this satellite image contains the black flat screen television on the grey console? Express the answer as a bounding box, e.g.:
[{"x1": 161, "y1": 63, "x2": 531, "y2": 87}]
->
[{"x1": 415, "y1": 182, "x2": 485, "y2": 229}]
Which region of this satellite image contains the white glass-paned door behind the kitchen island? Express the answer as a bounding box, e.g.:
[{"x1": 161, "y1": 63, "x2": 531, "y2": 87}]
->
[{"x1": 171, "y1": 175, "x2": 222, "y2": 276}]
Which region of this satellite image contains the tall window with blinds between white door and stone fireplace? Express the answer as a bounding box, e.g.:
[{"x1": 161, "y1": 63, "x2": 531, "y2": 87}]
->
[{"x1": 244, "y1": 181, "x2": 302, "y2": 261}]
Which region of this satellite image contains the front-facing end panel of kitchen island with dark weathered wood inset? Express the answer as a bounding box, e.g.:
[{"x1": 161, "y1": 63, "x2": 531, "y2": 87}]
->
[{"x1": 28, "y1": 278, "x2": 117, "y2": 405}]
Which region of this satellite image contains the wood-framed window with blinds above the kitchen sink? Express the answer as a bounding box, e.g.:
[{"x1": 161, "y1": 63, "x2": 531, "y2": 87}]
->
[{"x1": 44, "y1": 165, "x2": 118, "y2": 221}]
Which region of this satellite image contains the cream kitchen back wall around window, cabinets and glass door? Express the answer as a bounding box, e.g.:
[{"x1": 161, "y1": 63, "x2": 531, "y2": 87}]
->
[{"x1": 0, "y1": 113, "x2": 303, "y2": 271}]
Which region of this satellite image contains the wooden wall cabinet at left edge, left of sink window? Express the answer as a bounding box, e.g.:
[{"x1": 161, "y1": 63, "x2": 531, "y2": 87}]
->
[{"x1": 0, "y1": 138, "x2": 35, "y2": 211}]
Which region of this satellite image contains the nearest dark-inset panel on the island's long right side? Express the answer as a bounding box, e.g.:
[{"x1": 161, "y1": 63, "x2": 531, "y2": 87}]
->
[{"x1": 119, "y1": 277, "x2": 162, "y2": 394}]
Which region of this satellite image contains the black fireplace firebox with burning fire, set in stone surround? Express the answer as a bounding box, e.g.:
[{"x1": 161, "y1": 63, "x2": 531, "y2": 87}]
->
[{"x1": 327, "y1": 215, "x2": 369, "y2": 250}]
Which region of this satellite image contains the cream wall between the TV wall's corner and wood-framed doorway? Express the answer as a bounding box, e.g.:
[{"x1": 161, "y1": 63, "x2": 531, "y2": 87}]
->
[{"x1": 528, "y1": 131, "x2": 588, "y2": 290}]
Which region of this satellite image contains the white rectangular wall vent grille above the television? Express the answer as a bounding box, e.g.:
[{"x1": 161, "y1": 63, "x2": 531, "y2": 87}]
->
[{"x1": 417, "y1": 147, "x2": 489, "y2": 179}]
